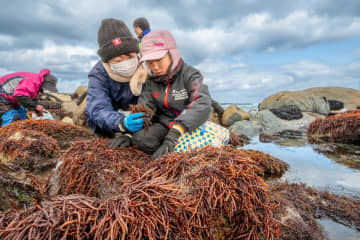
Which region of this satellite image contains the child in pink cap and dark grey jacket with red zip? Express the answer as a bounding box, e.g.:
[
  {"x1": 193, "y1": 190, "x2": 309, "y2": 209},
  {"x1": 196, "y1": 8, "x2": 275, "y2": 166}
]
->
[{"x1": 132, "y1": 31, "x2": 211, "y2": 158}]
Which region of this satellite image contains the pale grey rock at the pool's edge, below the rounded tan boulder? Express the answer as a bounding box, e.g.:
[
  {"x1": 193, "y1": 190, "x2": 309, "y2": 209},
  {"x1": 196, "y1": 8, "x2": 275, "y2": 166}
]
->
[{"x1": 258, "y1": 110, "x2": 323, "y2": 135}]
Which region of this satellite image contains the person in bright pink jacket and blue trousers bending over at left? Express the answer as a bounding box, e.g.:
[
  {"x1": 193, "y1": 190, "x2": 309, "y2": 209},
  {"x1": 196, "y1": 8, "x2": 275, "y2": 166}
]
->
[{"x1": 0, "y1": 69, "x2": 57, "y2": 126}]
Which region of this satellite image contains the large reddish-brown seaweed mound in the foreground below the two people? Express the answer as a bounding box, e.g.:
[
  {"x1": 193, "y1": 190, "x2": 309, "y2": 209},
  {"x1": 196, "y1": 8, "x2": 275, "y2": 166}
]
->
[{"x1": 0, "y1": 143, "x2": 280, "y2": 240}]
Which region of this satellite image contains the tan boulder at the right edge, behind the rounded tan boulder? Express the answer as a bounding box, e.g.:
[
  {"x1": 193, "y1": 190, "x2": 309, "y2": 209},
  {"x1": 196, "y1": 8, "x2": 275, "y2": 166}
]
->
[{"x1": 304, "y1": 87, "x2": 360, "y2": 110}]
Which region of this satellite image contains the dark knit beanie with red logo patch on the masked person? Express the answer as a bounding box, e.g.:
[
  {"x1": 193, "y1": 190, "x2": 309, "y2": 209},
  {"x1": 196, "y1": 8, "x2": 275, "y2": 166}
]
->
[{"x1": 98, "y1": 18, "x2": 139, "y2": 62}]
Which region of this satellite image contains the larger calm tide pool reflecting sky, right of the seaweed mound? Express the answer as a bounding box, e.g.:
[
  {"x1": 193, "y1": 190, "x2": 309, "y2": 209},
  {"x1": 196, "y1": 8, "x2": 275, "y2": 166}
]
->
[{"x1": 244, "y1": 138, "x2": 360, "y2": 197}]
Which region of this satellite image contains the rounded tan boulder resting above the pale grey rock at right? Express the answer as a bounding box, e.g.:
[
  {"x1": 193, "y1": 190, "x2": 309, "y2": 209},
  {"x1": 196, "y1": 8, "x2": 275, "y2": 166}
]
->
[{"x1": 259, "y1": 91, "x2": 330, "y2": 115}]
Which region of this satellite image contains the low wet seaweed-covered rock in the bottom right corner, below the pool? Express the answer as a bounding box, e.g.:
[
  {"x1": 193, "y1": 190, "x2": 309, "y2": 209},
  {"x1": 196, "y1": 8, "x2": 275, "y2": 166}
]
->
[{"x1": 272, "y1": 183, "x2": 360, "y2": 239}]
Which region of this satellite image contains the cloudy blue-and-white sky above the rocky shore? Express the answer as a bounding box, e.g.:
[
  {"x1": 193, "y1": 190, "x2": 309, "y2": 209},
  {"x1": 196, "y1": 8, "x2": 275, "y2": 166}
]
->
[{"x1": 0, "y1": 0, "x2": 360, "y2": 103}]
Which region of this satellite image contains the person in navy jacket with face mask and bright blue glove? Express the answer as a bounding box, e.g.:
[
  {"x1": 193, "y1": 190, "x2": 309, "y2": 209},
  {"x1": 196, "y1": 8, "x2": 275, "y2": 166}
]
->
[{"x1": 85, "y1": 18, "x2": 147, "y2": 148}]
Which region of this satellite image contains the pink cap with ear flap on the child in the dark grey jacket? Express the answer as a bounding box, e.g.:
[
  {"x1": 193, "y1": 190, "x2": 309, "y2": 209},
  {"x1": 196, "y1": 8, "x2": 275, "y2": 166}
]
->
[{"x1": 140, "y1": 30, "x2": 180, "y2": 70}]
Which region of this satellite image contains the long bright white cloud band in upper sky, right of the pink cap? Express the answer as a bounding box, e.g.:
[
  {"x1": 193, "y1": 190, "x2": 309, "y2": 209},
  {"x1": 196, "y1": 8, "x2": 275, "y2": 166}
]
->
[{"x1": 172, "y1": 10, "x2": 360, "y2": 58}]
